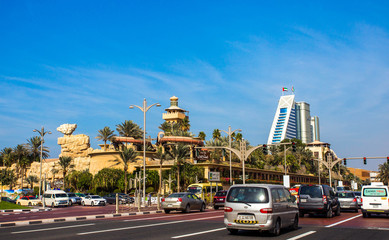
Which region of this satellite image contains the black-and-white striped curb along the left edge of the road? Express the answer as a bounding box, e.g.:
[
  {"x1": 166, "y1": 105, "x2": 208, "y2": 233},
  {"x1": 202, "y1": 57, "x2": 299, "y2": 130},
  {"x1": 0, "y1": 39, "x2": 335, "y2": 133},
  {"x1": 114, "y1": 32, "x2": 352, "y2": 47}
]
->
[{"x1": 0, "y1": 209, "x2": 163, "y2": 227}]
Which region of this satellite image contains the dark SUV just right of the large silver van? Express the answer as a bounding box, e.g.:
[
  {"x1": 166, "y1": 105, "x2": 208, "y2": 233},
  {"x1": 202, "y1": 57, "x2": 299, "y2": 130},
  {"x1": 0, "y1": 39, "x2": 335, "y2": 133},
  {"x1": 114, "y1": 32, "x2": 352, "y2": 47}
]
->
[{"x1": 298, "y1": 184, "x2": 340, "y2": 218}]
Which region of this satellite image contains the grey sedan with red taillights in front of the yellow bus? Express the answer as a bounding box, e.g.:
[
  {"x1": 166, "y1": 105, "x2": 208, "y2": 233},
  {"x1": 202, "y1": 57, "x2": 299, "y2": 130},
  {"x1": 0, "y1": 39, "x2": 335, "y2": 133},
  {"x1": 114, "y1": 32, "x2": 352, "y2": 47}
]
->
[{"x1": 162, "y1": 192, "x2": 205, "y2": 213}]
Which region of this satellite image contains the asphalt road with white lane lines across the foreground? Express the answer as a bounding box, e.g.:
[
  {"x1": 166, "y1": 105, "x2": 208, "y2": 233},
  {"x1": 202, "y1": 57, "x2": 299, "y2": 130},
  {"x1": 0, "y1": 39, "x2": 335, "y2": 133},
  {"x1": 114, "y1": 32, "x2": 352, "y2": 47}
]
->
[{"x1": 0, "y1": 210, "x2": 389, "y2": 240}]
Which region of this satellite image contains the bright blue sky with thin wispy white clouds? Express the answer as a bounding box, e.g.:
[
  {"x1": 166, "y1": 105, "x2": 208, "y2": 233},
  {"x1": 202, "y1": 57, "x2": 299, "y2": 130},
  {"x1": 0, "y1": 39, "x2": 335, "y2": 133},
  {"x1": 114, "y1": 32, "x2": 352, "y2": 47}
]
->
[{"x1": 0, "y1": 0, "x2": 389, "y2": 170}]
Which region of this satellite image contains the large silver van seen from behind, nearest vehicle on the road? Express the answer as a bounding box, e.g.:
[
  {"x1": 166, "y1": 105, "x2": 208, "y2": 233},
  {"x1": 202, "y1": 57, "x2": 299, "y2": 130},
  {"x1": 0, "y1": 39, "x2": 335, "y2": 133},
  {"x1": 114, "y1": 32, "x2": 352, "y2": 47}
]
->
[{"x1": 224, "y1": 184, "x2": 299, "y2": 236}]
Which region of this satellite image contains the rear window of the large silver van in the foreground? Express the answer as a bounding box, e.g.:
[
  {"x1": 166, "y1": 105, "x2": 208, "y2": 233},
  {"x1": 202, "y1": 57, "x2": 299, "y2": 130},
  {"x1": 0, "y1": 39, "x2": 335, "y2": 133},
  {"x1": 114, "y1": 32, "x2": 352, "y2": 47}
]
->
[{"x1": 227, "y1": 187, "x2": 269, "y2": 203}]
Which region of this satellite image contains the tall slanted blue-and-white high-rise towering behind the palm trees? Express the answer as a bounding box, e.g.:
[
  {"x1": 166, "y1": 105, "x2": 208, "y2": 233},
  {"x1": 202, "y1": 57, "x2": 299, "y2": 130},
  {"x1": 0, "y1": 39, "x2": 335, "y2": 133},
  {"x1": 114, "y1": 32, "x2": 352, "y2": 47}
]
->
[{"x1": 267, "y1": 95, "x2": 320, "y2": 144}]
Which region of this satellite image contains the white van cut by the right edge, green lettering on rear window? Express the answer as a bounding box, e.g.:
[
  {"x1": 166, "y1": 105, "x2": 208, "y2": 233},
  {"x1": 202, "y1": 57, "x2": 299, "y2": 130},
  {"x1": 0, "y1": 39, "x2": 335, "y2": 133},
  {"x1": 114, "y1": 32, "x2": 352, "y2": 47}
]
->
[{"x1": 361, "y1": 183, "x2": 389, "y2": 218}]
